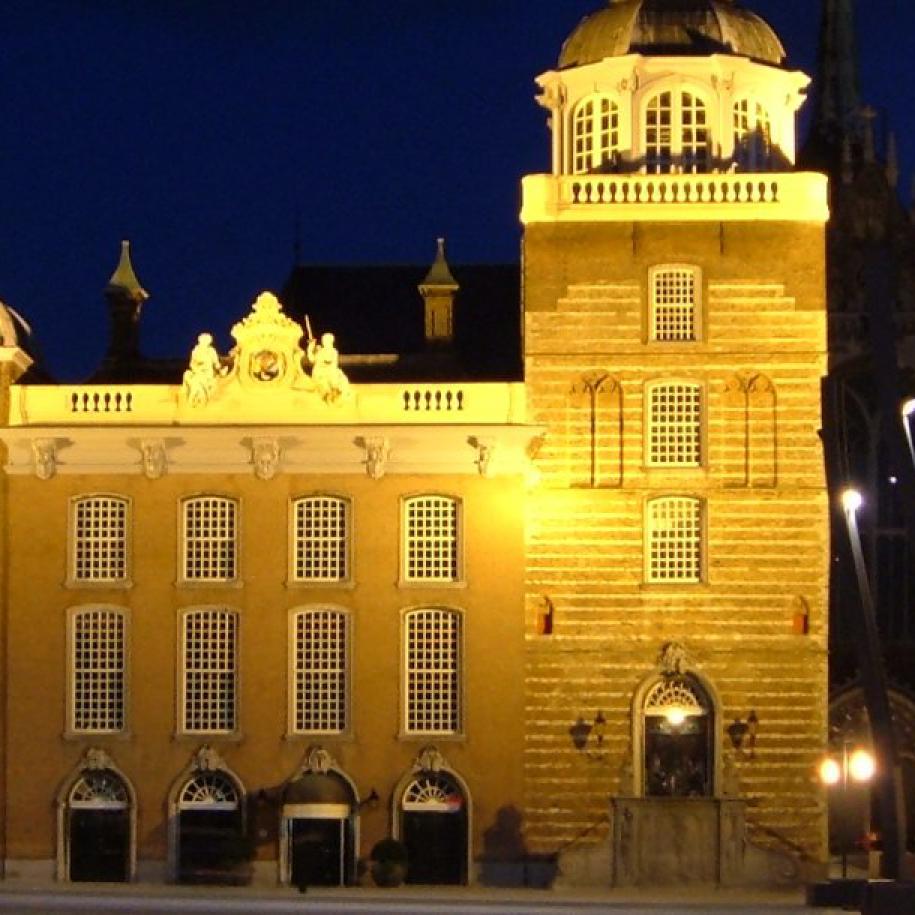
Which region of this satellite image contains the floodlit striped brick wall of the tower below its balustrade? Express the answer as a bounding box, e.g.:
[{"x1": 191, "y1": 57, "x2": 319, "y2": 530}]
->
[{"x1": 524, "y1": 215, "x2": 828, "y2": 860}]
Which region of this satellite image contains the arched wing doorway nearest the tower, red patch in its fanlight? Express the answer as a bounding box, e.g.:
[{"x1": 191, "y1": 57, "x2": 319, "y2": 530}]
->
[{"x1": 399, "y1": 748, "x2": 469, "y2": 884}]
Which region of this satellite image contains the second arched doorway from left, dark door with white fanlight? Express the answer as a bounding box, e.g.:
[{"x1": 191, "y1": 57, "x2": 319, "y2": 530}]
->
[{"x1": 175, "y1": 771, "x2": 246, "y2": 883}]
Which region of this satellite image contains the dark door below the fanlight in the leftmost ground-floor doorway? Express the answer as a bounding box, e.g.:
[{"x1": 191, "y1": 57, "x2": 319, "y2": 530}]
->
[{"x1": 70, "y1": 808, "x2": 130, "y2": 883}]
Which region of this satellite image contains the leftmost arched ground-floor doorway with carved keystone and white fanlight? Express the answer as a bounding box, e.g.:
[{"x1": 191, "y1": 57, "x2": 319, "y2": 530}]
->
[{"x1": 58, "y1": 750, "x2": 135, "y2": 883}]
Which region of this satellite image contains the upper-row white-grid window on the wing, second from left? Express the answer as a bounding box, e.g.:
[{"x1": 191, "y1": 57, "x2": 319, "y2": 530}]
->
[{"x1": 184, "y1": 496, "x2": 238, "y2": 581}]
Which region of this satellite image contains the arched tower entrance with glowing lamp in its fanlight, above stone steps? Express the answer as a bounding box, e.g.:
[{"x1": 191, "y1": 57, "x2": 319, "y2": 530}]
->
[{"x1": 642, "y1": 674, "x2": 715, "y2": 797}]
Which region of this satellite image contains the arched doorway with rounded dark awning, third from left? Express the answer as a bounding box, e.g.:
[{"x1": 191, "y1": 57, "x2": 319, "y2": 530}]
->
[{"x1": 280, "y1": 748, "x2": 359, "y2": 886}]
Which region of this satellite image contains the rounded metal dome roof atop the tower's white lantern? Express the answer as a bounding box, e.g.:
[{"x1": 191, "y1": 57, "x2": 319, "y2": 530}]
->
[{"x1": 559, "y1": 0, "x2": 785, "y2": 68}]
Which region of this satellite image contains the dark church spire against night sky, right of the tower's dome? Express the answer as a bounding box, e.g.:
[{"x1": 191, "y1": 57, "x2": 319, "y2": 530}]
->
[{"x1": 813, "y1": 0, "x2": 860, "y2": 143}]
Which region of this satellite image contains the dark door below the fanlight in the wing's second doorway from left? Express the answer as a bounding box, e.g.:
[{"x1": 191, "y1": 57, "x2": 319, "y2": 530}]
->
[{"x1": 178, "y1": 810, "x2": 243, "y2": 883}]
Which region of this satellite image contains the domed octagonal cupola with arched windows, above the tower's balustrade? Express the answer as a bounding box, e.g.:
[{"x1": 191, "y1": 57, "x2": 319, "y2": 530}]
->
[{"x1": 537, "y1": 0, "x2": 809, "y2": 175}]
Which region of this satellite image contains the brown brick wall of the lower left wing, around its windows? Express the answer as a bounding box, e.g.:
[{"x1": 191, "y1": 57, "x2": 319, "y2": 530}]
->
[{"x1": 0, "y1": 473, "x2": 523, "y2": 879}]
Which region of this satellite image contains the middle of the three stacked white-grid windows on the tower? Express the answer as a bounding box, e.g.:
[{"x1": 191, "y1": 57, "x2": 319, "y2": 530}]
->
[{"x1": 648, "y1": 382, "x2": 702, "y2": 467}]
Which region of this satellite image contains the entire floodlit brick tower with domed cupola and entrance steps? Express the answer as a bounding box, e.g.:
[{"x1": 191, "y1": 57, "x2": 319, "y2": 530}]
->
[{"x1": 521, "y1": 0, "x2": 828, "y2": 884}]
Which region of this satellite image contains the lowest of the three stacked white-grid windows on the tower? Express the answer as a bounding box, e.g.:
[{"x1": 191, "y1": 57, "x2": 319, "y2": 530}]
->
[{"x1": 646, "y1": 496, "x2": 702, "y2": 582}]
